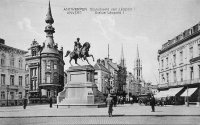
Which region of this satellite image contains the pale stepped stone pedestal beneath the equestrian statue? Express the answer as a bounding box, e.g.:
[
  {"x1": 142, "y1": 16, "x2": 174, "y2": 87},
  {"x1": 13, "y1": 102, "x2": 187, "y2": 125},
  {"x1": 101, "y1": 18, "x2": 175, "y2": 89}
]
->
[{"x1": 57, "y1": 65, "x2": 104, "y2": 107}]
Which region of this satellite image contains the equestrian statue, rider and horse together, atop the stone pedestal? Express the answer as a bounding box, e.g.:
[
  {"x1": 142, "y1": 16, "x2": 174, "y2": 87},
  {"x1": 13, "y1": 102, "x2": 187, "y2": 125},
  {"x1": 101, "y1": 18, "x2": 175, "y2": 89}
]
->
[{"x1": 65, "y1": 38, "x2": 94, "y2": 65}]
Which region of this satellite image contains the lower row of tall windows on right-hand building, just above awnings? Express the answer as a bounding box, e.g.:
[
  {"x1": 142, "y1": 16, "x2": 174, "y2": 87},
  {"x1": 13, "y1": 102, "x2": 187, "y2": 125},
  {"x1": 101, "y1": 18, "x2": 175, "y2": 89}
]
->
[{"x1": 162, "y1": 65, "x2": 200, "y2": 83}]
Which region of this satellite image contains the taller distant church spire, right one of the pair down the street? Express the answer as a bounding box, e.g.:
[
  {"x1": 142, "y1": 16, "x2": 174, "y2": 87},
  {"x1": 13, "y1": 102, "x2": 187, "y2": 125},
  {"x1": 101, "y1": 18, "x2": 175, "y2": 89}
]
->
[{"x1": 133, "y1": 45, "x2": 142, "y2": 81}]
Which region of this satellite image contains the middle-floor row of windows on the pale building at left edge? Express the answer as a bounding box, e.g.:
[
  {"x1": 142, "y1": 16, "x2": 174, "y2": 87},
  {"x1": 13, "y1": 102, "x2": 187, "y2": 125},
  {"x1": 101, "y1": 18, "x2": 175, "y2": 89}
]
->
[{"x1": 1, "y1": 74, "x2": 23, "y2": 86}]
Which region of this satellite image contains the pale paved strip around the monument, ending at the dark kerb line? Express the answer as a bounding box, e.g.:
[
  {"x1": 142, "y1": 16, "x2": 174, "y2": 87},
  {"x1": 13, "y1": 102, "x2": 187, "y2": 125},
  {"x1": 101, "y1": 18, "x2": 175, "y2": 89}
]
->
[{"x1": 0, "y1": 104, "x2": 200, "y2": 118}]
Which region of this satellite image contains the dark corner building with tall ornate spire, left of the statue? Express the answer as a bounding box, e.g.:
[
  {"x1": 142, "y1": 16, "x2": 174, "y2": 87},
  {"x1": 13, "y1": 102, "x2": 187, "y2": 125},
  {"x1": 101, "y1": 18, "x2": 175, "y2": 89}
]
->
[{"x1": 26, "y1": 2, "x2": 64, "y2": 102}]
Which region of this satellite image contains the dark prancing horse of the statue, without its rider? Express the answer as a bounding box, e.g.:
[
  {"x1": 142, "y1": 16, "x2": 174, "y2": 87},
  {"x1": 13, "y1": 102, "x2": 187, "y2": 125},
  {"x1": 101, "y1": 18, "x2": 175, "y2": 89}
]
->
[{"x1": 65, "y1": 42, "x2": 94, "y2": 66}]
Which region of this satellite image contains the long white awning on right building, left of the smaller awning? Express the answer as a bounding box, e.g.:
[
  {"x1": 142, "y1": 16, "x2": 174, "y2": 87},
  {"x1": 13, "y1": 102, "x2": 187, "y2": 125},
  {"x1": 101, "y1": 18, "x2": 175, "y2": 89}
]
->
[{"x1": 155, "y1": 87, "x2": 183, "y2": 98}]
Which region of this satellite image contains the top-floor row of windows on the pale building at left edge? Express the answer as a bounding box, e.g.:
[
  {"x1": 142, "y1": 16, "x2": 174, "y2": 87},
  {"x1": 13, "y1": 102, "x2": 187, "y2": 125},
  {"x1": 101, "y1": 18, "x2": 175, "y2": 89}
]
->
[{"x1": 1, "y1": 54, "x2": 23, "y2": 68}]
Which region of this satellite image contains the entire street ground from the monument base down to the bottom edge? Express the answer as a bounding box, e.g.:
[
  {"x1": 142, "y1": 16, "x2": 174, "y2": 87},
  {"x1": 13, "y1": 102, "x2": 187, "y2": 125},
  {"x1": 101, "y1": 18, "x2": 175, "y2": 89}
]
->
[{"x1": 0, "y1": 104, "x2": 200, "y2": 125}]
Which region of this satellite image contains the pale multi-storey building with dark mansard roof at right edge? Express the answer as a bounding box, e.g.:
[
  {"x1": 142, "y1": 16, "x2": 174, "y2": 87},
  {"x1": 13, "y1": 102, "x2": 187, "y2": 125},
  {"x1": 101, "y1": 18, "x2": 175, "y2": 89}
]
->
[{"x1": 158, "y1": 23, "x2": 200, "y2": 104}]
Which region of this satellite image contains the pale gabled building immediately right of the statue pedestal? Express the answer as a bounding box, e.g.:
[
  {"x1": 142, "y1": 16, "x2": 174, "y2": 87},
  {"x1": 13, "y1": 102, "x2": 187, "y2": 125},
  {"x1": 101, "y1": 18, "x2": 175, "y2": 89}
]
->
[{"x1": 94, "y1": 59, "x2": 110, "y2": 94}]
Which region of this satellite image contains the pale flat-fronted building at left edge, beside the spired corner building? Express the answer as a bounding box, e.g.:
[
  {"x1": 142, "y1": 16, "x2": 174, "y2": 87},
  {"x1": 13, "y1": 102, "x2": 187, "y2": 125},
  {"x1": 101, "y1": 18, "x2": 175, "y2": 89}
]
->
[{"x1": 0, "y1": 39, "x2": 27, "y2": 106}]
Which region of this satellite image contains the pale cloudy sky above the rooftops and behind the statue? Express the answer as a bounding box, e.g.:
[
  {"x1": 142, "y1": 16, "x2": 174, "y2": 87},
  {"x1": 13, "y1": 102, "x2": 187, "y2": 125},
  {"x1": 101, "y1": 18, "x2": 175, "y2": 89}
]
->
[{"x1": 0, "y1": 0, "x2": 200, "y2": 84}]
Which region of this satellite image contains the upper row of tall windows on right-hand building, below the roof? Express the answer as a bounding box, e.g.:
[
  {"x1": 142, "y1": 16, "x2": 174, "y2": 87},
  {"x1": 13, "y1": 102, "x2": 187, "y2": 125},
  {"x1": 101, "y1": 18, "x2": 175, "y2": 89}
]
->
[{"x1": 161, "y1": 44, "x2": 200, "y2": 69}]
